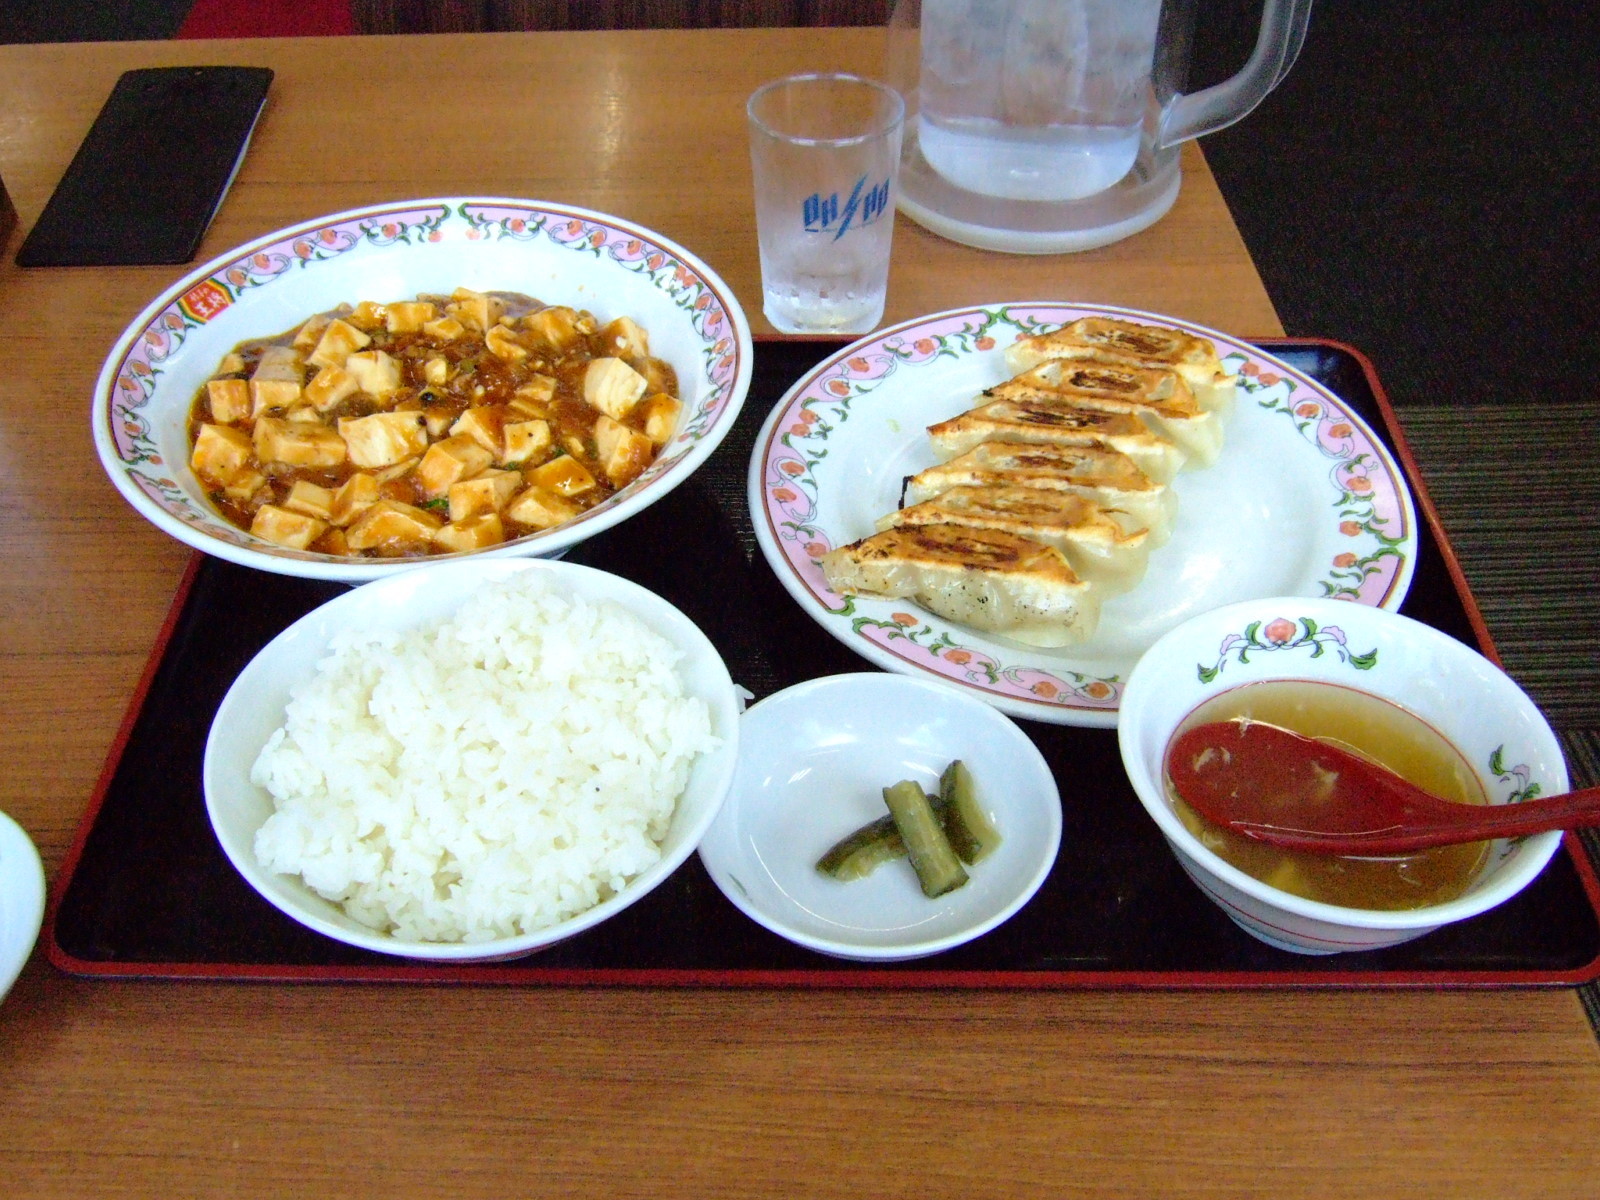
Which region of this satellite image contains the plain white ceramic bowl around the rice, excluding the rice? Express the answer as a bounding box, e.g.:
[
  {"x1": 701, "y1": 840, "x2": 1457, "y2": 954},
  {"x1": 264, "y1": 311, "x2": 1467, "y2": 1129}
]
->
[{"x1": 202, "y1": 558, "x2": 739, "y2": 962}]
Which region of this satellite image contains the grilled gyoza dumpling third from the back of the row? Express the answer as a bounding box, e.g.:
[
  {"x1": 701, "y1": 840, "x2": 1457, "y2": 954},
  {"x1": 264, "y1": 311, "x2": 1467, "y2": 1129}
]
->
[{"x1": 928, "y1": 400, "x2": 1187, "y2": 483}]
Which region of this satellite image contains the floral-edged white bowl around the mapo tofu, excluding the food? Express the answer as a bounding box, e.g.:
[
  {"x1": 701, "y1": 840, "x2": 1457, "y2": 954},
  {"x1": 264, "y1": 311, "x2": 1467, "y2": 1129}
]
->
[{"x1": 91, "y1": 197, "x2": 752, "y2": 582}]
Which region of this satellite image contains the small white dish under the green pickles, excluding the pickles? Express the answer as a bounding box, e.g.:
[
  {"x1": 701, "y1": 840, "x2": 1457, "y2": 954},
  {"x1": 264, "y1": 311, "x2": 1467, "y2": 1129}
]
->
[{"x1": 699, "y1": 674, "x2": 1061, "y2": 962}]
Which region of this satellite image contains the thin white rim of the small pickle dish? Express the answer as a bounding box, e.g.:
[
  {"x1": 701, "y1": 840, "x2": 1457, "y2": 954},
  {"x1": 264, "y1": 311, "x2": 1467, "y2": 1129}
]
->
[{"x1": 701, "y1": 670, "x2": 1064, "y2": 963}]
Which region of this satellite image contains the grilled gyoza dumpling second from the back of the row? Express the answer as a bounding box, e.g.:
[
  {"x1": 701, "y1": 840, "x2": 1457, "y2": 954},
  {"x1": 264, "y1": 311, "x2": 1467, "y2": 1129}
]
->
[{"x1": 984, "y1": 358, "x2": 1222, "y2": 467}]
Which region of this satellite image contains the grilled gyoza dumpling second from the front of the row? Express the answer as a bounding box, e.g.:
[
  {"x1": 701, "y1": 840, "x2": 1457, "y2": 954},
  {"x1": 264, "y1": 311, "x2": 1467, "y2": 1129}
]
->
[{"x1": 878, "y1": 486, "x2": 1150, "y2": 592}]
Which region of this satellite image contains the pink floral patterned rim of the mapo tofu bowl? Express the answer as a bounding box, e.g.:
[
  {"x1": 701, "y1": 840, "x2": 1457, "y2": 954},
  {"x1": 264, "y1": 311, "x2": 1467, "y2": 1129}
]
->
[{"x1": 90, "y1": 195, "x2": 755, "y2": 582}]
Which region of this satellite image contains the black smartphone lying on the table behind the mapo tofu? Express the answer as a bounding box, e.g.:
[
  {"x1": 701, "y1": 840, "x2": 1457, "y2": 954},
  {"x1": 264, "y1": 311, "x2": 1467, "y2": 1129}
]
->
[{"x1": 16, "y1": 67, "x2": 272, "y2": 267}]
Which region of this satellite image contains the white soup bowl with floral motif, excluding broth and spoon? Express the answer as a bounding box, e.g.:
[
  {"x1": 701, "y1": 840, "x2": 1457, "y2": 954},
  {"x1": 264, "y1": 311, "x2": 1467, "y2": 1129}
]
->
[{"x1": 1117, "y1": 597, "x2": 1568, "y2": 954}]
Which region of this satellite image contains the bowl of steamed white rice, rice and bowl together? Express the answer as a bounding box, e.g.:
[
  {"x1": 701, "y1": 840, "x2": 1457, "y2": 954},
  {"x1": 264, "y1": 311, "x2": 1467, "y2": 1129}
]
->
[{"x1": 203, "y1": 558, "x2": 739, "y2": 962}]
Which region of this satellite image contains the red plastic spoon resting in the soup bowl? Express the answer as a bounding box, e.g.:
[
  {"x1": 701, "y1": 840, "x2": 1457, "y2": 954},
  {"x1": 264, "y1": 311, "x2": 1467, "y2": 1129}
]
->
[{"x1": 1166, "y1": 720, "x2": 1600, "y2": 854}]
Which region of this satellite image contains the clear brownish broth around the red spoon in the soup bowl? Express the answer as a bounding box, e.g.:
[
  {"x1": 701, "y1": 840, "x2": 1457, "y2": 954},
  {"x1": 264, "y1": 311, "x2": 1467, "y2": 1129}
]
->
[{"x1": 1166, "y1": 680, "x2": 1490, "y2": 910}]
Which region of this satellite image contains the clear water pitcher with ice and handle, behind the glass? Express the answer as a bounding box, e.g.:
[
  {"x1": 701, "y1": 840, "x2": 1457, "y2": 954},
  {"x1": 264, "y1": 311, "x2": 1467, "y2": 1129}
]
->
[{"x1": 890, "y1": 0, "x2": 1310, "y2": 254}]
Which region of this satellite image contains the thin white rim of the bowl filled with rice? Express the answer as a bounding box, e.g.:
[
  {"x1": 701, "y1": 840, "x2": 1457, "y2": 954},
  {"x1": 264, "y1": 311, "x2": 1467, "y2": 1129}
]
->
[{"x1": 202, "y1": 558, "x2": 739, "y2": 962}]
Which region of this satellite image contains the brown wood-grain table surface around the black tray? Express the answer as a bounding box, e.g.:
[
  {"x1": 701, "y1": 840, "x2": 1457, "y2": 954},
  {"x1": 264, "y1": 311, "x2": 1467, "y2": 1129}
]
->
[{"x1": 0, "y1": 29, "x2": 1600, "y2": 1200}]
